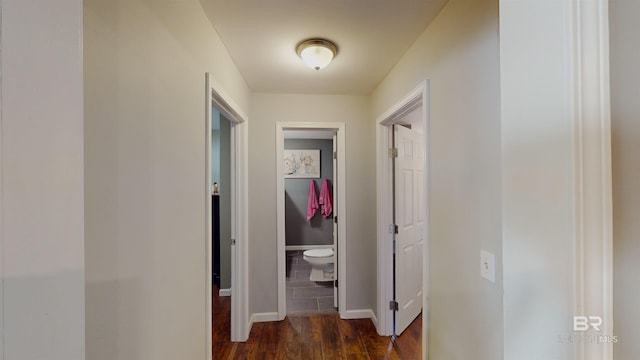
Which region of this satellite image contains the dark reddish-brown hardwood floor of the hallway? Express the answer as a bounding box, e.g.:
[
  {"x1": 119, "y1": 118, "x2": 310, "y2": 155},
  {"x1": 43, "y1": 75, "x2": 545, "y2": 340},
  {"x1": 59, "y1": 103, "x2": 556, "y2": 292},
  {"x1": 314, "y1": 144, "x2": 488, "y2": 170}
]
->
[{"x1": 213, "y1": 289, "x2": 422, "y2": 360}]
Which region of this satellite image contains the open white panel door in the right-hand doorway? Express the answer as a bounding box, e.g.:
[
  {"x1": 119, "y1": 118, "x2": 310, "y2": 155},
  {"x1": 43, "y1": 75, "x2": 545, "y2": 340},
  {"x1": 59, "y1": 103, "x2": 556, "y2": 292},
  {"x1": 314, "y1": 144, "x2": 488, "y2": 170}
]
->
[{"x1": 394, "y1": 125, "x2": 426, "y2": 335}]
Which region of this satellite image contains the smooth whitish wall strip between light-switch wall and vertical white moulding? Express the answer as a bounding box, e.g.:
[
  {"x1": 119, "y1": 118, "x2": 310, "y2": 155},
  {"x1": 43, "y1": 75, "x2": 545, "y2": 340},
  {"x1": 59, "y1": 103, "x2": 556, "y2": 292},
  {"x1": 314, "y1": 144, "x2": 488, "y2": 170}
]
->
[{"x1": 500, "y1": 1, "x2": 573, "y2": 360}]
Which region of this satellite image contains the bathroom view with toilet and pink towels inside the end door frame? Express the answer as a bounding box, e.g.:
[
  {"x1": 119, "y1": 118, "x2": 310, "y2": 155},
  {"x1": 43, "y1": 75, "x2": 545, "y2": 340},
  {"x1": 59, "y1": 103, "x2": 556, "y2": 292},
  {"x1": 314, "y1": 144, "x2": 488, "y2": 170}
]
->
[{"x1": 283, "y1": 130, "x2": 338, "y2": 315}]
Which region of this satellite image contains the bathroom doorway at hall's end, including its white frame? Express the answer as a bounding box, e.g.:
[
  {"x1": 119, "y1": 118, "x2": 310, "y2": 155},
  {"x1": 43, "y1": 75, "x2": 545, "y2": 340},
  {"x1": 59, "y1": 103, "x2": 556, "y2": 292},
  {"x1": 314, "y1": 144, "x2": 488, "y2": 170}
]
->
[{"x1": 276, "y1": 123, "x2": 347, "y2": 320}]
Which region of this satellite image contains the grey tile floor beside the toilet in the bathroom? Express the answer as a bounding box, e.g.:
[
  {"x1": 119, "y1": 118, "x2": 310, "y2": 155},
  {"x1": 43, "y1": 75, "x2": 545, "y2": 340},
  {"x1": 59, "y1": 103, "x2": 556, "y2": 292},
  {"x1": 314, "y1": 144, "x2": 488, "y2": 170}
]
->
[{"x1": 286, "y1": 250, "x2": 337, "y2": 314}]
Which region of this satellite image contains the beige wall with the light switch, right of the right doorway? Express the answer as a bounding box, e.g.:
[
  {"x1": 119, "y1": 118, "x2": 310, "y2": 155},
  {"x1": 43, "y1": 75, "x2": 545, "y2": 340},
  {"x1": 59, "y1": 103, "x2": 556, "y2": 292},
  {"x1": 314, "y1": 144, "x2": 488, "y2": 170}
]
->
[{"x1": 372, "y1": 0, "x2": 502, "y2": 360}]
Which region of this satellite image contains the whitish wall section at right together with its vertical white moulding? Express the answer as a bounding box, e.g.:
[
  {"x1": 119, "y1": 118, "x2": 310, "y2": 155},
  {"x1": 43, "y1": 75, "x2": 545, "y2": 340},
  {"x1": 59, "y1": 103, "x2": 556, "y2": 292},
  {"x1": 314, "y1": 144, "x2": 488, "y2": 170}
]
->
[{"x1": 500, "y1": 0, "x2": 614, "y2": 360}]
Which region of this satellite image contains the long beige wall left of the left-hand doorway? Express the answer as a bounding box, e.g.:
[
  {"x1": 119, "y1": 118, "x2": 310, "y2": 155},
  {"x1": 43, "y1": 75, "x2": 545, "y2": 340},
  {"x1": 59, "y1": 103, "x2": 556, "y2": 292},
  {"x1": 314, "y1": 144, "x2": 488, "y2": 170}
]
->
[{"x1": 84, "y1": 0, "x2": 250, "y2": 360}]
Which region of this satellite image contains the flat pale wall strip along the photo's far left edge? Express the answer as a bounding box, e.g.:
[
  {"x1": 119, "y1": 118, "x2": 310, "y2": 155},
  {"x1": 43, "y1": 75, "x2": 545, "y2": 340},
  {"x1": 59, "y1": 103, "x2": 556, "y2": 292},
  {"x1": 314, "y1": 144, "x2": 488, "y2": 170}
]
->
[{"x1": 0, "y1": 0, "x2": 85, "y2": 360}]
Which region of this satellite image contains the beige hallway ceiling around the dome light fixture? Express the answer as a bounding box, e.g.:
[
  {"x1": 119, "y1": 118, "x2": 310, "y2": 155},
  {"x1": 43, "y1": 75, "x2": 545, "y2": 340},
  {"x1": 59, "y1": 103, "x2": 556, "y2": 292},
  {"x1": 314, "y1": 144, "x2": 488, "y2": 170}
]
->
[{"x1": 200, "y1": 0, "x2": 447, "y2": 94}]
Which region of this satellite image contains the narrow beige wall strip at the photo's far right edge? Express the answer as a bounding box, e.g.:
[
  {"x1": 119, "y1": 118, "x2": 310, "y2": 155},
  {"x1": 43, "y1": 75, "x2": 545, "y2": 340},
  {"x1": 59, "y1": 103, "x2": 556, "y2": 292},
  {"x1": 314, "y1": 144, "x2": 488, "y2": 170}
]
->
[{"x1": 609, "y1": 0, "x2": 640, "y2": 359}]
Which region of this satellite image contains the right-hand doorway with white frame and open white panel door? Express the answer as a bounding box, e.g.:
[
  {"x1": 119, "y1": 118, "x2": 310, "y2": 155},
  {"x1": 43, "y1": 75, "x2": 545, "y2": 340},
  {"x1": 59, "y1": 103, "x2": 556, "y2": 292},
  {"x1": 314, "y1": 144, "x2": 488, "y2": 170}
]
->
[{"x1": 376, "y1": 81, "x2": 429, "y2": 359}]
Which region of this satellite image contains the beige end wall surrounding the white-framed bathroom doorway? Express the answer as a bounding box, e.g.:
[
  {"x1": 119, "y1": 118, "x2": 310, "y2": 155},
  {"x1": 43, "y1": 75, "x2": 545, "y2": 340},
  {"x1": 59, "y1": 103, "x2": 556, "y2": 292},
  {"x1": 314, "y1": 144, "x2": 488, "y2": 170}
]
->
[{"x1": 249, "y1": 94, "x2": 376, "y2": 313}]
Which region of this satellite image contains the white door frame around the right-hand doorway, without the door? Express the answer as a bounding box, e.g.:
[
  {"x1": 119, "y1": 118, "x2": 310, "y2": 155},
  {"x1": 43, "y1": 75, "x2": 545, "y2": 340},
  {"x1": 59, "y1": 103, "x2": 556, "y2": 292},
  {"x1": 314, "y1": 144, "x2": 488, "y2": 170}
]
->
[{"x1": 376, "y1": 80, "x2": 429, "y2": 348}]
